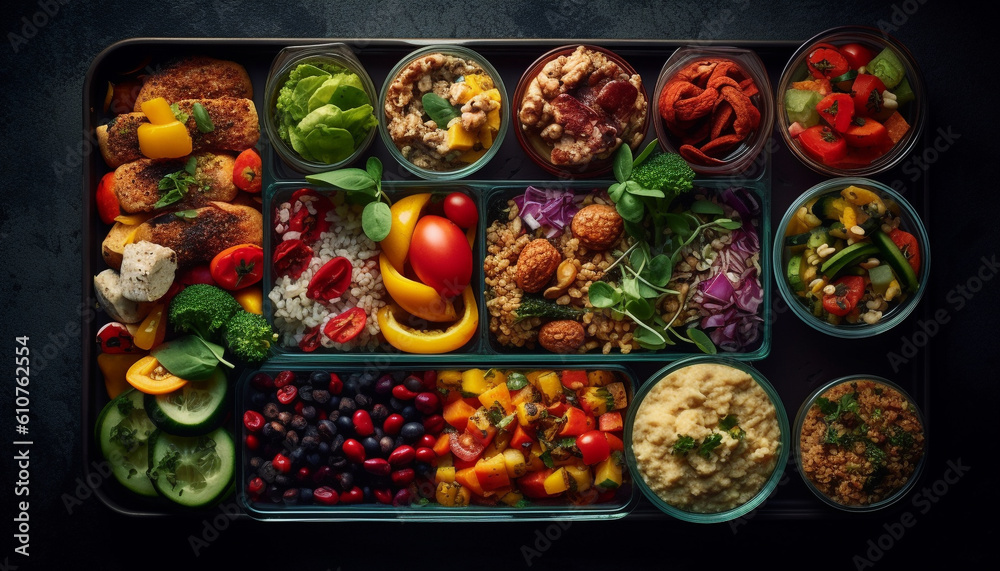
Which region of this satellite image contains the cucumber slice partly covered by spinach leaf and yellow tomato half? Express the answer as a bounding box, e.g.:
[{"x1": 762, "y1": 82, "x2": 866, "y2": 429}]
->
[{"x1": 144, "y1": 367, "x2": 229, "y2": 436}]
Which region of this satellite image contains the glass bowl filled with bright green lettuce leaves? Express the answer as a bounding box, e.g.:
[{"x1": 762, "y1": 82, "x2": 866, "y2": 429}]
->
[{"x1": 264, "y1": 43, "x2": 378, "y2": 174}]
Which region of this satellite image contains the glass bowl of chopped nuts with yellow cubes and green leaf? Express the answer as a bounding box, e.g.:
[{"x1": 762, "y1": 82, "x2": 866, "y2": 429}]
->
[{"x1": 378, "y1": 45, "x2": 510, "y2": 180}]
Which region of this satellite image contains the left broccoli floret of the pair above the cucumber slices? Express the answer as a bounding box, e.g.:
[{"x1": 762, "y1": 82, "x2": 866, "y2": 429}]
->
[{"x1": 169, "y1": 284, "x2": 243, "y2": 341}]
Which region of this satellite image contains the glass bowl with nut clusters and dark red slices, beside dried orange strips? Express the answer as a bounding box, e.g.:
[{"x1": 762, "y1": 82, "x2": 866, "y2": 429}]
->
[{"x1": 512, "y1": 44, "x2": 649, "y2": 178}]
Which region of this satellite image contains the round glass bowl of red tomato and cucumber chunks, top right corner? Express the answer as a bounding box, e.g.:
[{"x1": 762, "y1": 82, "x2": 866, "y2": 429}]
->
[{"x1": 776, "y1": 26, "x2": 927, "y2": 176}]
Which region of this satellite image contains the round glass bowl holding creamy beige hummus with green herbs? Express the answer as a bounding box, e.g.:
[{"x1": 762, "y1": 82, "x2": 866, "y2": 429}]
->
[{"x1": 625, "y1": 356, "x2": 791, "y2": 523}]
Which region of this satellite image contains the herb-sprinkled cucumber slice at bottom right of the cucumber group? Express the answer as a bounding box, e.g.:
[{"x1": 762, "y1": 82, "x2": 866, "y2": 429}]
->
[{"x1": 149, "y1": 428, "x2": 236, "y2": 508}]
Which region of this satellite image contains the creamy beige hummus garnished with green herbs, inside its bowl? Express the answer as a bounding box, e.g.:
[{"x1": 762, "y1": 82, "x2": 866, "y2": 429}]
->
[{"x1": 632, "y1": 363, "x2": 781, "y2": 513}]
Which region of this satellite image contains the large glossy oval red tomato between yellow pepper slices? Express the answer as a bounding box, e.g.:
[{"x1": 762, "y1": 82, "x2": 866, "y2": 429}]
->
[{"x1": 410, "y1": 216, "x2": 472, "y2": 297}]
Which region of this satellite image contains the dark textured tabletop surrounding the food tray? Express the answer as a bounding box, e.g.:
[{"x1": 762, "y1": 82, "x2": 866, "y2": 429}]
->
[{"x1": 0, "y1": 0, "x2": 998, "y2": 570}]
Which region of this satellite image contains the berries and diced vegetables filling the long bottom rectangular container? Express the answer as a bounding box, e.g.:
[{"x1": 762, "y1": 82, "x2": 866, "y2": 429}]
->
[{"x1": 243, "y1": 368, "x2": 630, "y2": 508}]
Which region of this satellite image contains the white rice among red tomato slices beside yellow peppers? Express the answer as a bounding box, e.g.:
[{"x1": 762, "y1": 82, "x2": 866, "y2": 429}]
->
[{"x1": 267, "y1": 193, "x2": 388, "y2": 351}]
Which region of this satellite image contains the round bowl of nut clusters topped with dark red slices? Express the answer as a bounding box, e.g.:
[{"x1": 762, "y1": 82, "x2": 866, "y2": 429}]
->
[{"x1": 512, "y1": 44, "x2": 649, "y2": 178}]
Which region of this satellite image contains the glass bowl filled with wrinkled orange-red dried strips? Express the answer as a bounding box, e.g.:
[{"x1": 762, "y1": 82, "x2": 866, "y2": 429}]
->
[{"x1": 653, "y1": 46, "x2": 774, "y2": 176}]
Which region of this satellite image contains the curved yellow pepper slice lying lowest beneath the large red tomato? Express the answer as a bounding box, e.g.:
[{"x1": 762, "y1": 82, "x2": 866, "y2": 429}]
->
[{"x1": 377, "y1": 286, "x2": 479, "y2": 354}]
